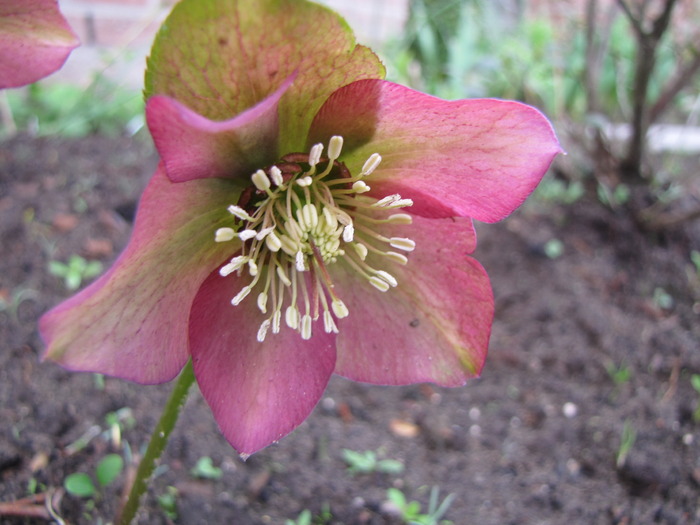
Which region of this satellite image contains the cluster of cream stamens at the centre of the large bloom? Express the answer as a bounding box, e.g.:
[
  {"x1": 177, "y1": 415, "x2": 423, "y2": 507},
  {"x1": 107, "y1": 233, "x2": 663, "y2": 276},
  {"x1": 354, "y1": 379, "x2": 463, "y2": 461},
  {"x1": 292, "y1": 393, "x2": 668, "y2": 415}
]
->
[{"x1": 215, "y1": 136, "x2": 415, "y2": 342}]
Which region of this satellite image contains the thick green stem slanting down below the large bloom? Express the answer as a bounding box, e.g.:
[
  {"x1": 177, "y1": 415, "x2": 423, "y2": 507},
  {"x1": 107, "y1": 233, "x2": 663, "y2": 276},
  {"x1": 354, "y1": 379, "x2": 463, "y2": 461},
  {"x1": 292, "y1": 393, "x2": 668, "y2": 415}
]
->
[{"x1": 115, "y1": 361, "x2": 194, "y2": 525}]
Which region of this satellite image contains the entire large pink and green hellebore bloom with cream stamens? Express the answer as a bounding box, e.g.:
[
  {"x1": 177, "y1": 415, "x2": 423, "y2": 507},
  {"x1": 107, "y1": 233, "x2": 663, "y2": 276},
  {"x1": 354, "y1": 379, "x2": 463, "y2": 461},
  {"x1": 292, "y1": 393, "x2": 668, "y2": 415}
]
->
[{"x1": 40, "y1": 0, "x2": 561, "y2": 455}]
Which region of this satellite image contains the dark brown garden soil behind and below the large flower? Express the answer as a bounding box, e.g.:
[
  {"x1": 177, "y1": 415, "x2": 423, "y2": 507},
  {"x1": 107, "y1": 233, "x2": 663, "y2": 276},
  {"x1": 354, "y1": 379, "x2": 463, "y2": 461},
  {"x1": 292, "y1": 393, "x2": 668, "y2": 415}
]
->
[{"x1": 0, "y1": 137, "x2": 700, "y2": 525}]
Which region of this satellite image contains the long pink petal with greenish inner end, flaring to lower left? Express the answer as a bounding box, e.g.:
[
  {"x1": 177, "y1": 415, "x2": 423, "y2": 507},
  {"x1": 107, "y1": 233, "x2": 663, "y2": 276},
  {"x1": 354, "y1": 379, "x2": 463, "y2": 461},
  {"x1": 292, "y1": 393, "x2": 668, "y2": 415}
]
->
[{"x1": 39, "y1": 167, "x2": 240, "y2": 383}]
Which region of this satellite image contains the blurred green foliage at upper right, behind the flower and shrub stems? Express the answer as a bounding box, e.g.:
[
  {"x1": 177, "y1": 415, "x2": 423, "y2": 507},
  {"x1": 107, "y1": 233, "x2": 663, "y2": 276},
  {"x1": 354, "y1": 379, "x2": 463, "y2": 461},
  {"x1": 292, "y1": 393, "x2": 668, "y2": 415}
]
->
[{"x1": 389, "y1": 0, "x2": 700, "y2": 121}]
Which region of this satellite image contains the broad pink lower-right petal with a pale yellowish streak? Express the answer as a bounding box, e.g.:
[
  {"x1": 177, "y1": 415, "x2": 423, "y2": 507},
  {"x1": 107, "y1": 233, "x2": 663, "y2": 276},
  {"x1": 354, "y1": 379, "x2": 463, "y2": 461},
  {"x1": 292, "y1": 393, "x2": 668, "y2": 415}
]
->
[{"x1": 329, "y1": 217, "x2": 494, "y2": 386}]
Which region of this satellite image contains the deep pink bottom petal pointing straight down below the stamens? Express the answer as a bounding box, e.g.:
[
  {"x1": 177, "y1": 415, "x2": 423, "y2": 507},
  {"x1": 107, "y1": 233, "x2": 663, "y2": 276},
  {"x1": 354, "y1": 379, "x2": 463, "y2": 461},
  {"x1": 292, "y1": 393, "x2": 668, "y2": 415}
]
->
[{"x1": 190, "y1": 266, "x2": 335, "y2": 455}]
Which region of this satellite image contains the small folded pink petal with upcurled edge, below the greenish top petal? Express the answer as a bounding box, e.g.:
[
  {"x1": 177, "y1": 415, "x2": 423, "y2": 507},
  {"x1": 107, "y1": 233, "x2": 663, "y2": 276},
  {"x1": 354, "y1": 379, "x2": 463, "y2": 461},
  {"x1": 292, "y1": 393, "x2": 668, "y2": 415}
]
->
[{"x1": 146, "y1": 75, "x2": 295, "y2": 182}]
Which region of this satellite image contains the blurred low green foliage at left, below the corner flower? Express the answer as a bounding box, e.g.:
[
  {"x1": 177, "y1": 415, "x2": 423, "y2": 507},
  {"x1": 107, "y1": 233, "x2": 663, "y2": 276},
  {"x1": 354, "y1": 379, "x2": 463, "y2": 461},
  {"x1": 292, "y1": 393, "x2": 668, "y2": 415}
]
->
[{"x1": 6, "y1": 74, "x2": 144, "y2": 137}]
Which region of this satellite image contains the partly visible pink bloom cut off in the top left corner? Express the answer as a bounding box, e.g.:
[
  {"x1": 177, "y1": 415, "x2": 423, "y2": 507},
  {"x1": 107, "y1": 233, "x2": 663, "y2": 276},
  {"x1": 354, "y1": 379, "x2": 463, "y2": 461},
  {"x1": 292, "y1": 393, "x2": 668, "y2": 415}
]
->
[{"x1": 0, "y1": 0, "x2": 79, "y2": 89}]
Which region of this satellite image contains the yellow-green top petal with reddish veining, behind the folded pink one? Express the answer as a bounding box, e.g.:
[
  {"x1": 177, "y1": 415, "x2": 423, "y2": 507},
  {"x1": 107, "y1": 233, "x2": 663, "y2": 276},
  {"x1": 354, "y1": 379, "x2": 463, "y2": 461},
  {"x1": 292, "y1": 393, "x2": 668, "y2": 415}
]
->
[{"x1": 145, "y1": 0, "x2": 384, "y2": 154}]
